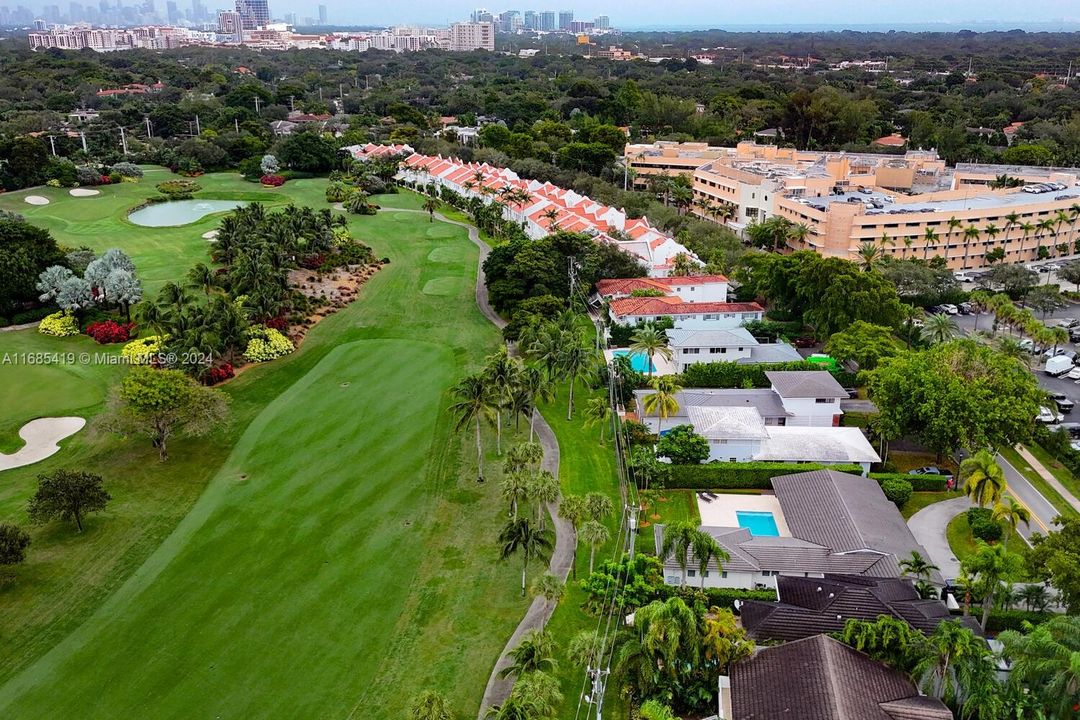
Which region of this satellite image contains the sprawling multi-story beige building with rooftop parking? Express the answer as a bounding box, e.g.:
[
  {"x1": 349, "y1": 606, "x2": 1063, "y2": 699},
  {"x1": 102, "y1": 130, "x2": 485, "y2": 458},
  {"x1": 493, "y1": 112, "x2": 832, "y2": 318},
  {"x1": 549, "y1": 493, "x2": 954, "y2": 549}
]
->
[{"x1": 626, "y1": 142, "x2": 1080, "y2": 270}]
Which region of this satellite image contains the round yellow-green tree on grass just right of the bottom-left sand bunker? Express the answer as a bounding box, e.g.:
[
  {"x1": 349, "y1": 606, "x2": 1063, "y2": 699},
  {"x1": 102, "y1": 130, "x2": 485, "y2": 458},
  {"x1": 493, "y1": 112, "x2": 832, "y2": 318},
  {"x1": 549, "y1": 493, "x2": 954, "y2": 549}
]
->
[{"x1": 108, "y1": 366, "x2": 229, "y2": 462}]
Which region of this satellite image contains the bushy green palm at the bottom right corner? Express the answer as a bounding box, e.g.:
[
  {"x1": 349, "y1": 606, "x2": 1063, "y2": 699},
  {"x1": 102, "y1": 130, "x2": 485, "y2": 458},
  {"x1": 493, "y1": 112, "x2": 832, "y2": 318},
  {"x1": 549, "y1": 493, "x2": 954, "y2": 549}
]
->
[{"x1": 999, "y1": 615, "x2": 1080, "y2": 718}]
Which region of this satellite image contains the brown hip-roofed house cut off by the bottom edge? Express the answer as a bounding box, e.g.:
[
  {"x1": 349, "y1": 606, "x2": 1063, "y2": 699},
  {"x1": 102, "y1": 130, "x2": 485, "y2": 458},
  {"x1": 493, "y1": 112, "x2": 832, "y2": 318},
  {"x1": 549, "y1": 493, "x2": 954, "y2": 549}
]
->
[{"x1": 719, "y1": 635, "x2": 954, "y2": 720}]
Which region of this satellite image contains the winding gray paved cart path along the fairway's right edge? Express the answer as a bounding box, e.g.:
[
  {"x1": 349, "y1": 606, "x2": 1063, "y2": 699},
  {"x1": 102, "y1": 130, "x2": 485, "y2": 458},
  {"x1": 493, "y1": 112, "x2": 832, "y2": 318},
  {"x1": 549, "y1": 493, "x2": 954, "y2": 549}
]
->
[{"x1": 380, "y1": 207, "x2": 576, "y2": 720}]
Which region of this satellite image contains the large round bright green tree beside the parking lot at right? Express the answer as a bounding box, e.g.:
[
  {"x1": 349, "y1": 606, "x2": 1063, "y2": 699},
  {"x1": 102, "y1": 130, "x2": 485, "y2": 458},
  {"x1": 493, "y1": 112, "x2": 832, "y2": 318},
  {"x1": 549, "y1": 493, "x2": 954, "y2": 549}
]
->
[{"x1": 868, "y1": 340, "x2": 1043, "y2": 454}]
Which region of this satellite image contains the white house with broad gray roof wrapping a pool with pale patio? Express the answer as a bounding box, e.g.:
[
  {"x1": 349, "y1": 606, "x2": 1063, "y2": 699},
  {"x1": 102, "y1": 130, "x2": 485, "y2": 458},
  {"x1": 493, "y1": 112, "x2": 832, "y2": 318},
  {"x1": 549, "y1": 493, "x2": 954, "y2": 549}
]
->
[{"x1": 653, "y1": 470, "x2": 941, "y2": 588}]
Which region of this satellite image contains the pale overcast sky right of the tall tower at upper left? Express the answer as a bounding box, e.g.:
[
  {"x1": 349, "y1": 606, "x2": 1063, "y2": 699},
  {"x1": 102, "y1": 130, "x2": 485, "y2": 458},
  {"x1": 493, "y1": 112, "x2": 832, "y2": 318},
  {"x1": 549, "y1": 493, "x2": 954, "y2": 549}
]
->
[{"x1": 278, "y1": 0, "x2": 1080, "y2": 28}]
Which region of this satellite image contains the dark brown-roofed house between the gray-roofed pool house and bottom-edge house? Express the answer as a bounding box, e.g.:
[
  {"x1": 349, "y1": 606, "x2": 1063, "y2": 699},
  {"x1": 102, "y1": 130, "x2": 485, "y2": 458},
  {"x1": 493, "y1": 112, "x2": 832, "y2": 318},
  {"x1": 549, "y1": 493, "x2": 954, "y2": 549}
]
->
[{"x1": 739, "y1": 573, "x2": 983, "y2": 642}]
